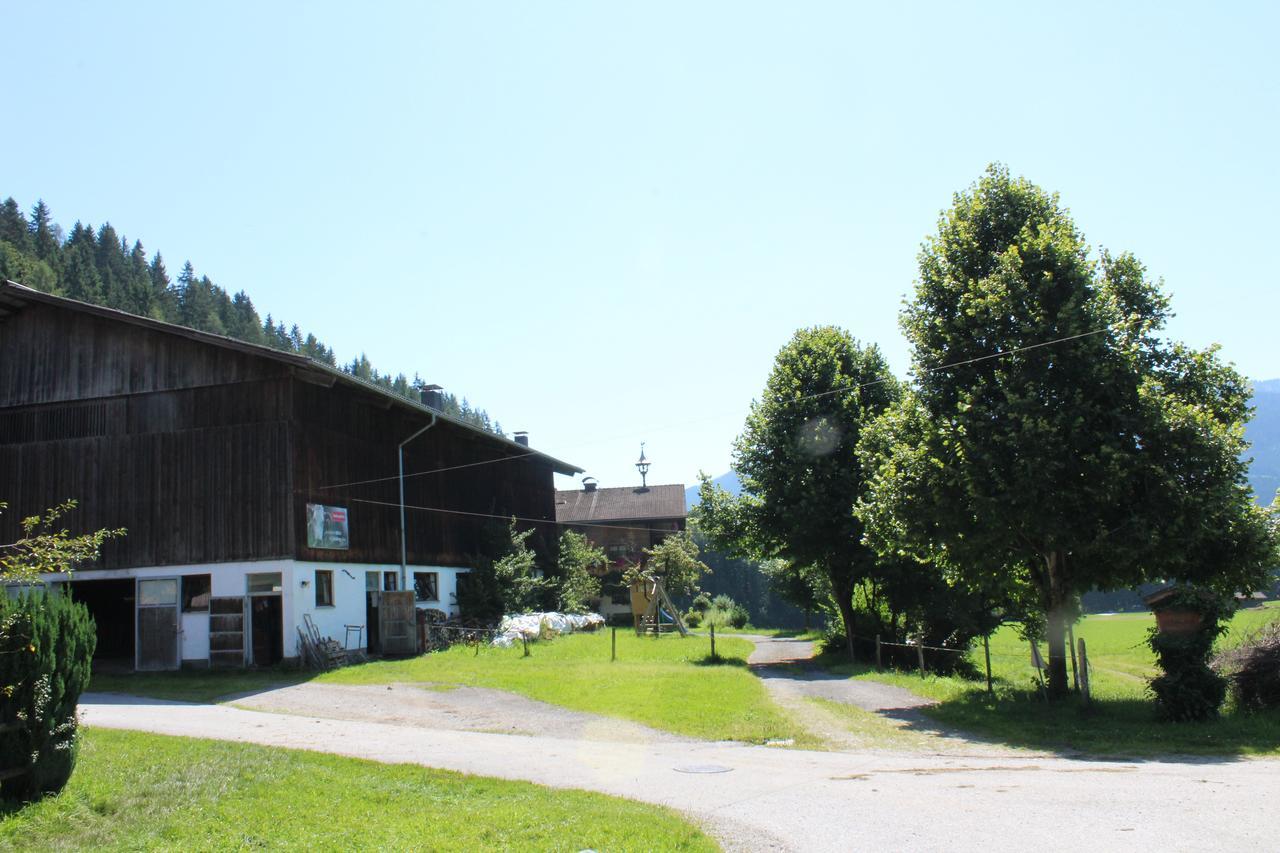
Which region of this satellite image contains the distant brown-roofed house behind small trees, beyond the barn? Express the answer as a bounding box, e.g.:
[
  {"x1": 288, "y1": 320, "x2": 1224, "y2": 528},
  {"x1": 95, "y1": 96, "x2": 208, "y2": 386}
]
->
[{"x1": 556, "y1": 468, "x2": 687, "y2": 616}]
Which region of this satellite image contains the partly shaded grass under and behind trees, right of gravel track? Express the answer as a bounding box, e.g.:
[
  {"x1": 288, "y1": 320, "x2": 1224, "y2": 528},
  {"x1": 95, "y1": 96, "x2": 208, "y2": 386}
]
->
[{"x1": 822, "y1": 607, "x2": 1280, "y2": 756}]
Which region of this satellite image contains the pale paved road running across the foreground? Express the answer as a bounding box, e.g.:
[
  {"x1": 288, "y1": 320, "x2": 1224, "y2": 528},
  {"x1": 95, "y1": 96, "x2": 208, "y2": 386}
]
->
[{"x1": 81, "y1": 694, "x2": 1280, "y2": 852}]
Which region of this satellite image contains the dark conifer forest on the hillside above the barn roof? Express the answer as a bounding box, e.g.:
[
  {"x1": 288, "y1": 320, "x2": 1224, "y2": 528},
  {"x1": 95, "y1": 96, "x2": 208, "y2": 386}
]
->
[{"x1": 0, "y1": 197, "x2": 504, "y2": 435}]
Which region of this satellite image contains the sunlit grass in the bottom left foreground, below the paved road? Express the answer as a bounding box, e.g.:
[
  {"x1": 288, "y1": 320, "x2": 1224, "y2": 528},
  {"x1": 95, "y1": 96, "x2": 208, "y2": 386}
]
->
[{"x1": 0, "y1": 729, "x2": 718, "y2": 850}]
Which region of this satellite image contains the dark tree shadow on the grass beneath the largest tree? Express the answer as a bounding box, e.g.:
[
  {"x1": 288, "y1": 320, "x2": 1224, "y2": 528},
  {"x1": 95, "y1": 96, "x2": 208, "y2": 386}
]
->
[{"x1": 879, "y1": 690, "x2": 1280, "y2": 763}]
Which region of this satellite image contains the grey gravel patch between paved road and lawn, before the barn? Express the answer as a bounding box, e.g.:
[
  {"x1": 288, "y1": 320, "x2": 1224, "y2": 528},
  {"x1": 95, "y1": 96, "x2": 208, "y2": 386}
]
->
[{"x1": 229, "y1": 681, "x2": 684, "y2": 743}]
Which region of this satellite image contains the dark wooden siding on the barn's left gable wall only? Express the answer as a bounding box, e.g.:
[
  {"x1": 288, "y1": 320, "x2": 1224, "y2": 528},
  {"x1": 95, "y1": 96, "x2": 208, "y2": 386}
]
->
[{"x1": 0, "y1": 305, "x2": 292, "y2": 569}]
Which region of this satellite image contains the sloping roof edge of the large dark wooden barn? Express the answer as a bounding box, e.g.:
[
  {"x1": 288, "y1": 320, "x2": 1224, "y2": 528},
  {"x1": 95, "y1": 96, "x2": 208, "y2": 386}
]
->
[{"x1": 0, "y1": 279, "x2": 582, "y2": 476}]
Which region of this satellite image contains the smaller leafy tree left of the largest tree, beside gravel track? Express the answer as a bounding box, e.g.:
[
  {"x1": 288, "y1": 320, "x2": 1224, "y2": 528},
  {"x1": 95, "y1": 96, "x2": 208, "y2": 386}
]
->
[{"x1": 695, "y1": 327, "x2": 900, "y2": 657}]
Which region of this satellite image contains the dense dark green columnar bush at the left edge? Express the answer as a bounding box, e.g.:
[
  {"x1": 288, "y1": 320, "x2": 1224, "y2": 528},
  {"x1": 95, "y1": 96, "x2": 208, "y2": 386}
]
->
[{"x1": 0, "y1": 589, "x2": 97, "y2": 800}]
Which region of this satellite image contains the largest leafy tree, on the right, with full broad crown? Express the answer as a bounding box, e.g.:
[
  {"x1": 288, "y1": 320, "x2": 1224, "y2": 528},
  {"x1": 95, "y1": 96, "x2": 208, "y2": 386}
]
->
[{"x1": 859, "y1": 167, "x2": 1275, "y2": 694}]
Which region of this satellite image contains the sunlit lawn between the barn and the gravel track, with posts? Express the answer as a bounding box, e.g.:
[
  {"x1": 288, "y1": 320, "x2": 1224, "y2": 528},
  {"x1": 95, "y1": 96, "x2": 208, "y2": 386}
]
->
[{"x1": 317, "y1": 630, "x2": 808, "y2": 743}]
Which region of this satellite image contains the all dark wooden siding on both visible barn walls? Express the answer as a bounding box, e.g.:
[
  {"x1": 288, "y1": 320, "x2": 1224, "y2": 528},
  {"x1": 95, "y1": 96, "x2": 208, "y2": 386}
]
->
[{"x1": 0, "y1": 295, "x2": 558, "y2": 569}]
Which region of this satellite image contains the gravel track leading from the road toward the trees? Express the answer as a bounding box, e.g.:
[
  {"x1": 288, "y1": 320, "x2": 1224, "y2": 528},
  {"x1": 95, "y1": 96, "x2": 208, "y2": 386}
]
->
[{"x1": 741, "y1": 634, "x2": 1030, "y2": 756}]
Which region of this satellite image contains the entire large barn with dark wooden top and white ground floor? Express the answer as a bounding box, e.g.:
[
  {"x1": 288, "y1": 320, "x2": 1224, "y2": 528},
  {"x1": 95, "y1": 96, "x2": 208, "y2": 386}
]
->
[{"x1": 0, "y1": 282, "x2": 581, "y2": 670}]
